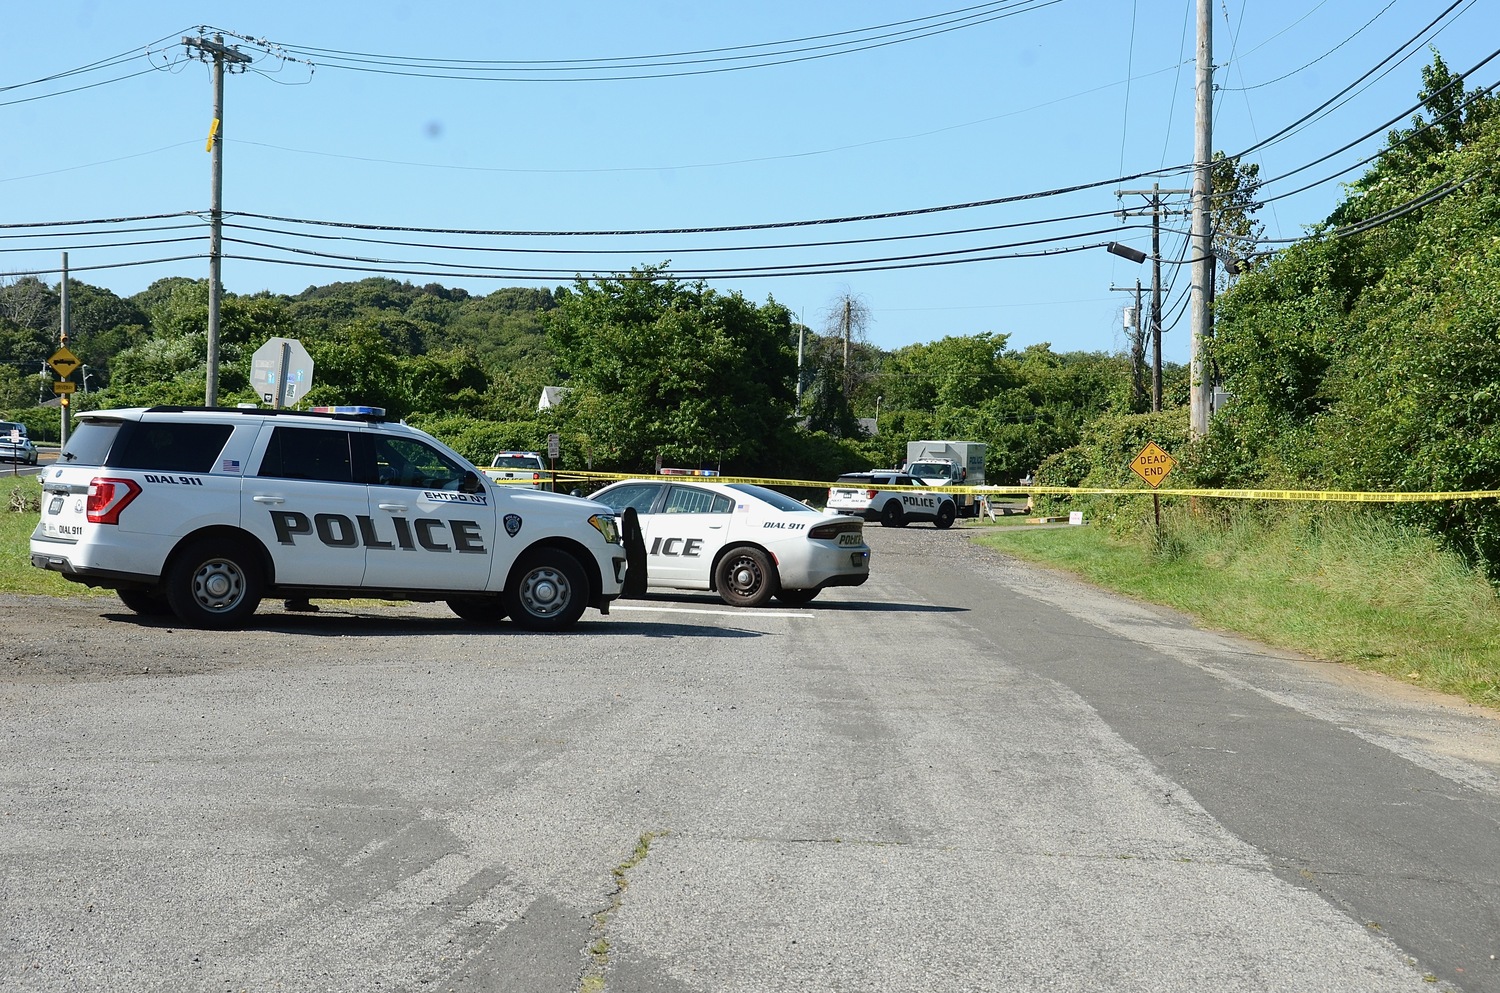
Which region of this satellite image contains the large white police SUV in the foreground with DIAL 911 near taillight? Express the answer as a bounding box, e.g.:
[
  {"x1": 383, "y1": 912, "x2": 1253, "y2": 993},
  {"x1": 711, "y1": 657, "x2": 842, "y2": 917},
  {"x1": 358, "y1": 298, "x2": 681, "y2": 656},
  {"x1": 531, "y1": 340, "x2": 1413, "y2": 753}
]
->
[{"x1": 32, "y1": 407, "x2": 627, "y2": 630}]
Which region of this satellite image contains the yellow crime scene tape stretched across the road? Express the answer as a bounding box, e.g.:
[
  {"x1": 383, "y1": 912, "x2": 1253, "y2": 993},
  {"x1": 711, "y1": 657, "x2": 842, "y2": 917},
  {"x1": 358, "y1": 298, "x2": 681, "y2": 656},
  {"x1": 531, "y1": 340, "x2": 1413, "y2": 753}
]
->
[{"x1": 494, "y1": 470, "x2": 1500, "y2": 504}]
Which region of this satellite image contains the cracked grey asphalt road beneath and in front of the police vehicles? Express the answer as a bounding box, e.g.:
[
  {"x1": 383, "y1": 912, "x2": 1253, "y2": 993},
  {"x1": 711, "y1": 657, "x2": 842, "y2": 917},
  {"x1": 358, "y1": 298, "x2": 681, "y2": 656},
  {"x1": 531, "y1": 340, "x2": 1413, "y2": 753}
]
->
[{"x1": 0, "y1": 527, "x2": 1500, "y2": 993}]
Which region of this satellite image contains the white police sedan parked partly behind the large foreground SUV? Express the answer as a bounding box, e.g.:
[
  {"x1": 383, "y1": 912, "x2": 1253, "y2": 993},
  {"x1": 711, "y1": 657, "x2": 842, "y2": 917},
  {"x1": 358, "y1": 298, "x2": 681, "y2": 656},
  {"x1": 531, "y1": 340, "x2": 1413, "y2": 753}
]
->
[{"x1": 590, "y1": 479, "x2": 870, "y2": 608}]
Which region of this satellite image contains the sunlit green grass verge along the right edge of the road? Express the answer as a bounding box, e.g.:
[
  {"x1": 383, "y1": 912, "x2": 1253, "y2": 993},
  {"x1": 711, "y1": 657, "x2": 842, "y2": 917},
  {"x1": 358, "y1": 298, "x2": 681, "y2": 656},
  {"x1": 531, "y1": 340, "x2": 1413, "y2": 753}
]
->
[{"x1": 980, "y1": 506, "x2": 1500, "y2": 708}]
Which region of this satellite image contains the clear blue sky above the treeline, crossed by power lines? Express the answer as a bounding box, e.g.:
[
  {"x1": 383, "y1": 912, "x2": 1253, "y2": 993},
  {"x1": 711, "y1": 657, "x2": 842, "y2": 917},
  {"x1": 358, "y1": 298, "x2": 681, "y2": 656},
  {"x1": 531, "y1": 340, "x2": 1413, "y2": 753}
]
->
[{"x1": 0, "y1": 0, "x2": 1500, "y2": 362}]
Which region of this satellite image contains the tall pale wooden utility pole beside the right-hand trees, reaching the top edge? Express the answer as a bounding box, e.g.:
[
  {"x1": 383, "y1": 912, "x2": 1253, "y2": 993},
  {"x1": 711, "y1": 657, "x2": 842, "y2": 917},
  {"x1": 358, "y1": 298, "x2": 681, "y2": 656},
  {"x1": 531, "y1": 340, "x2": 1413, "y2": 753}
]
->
[{"x1": 1188, "y1": 0, "x2": 1214, "y2": 438}]
